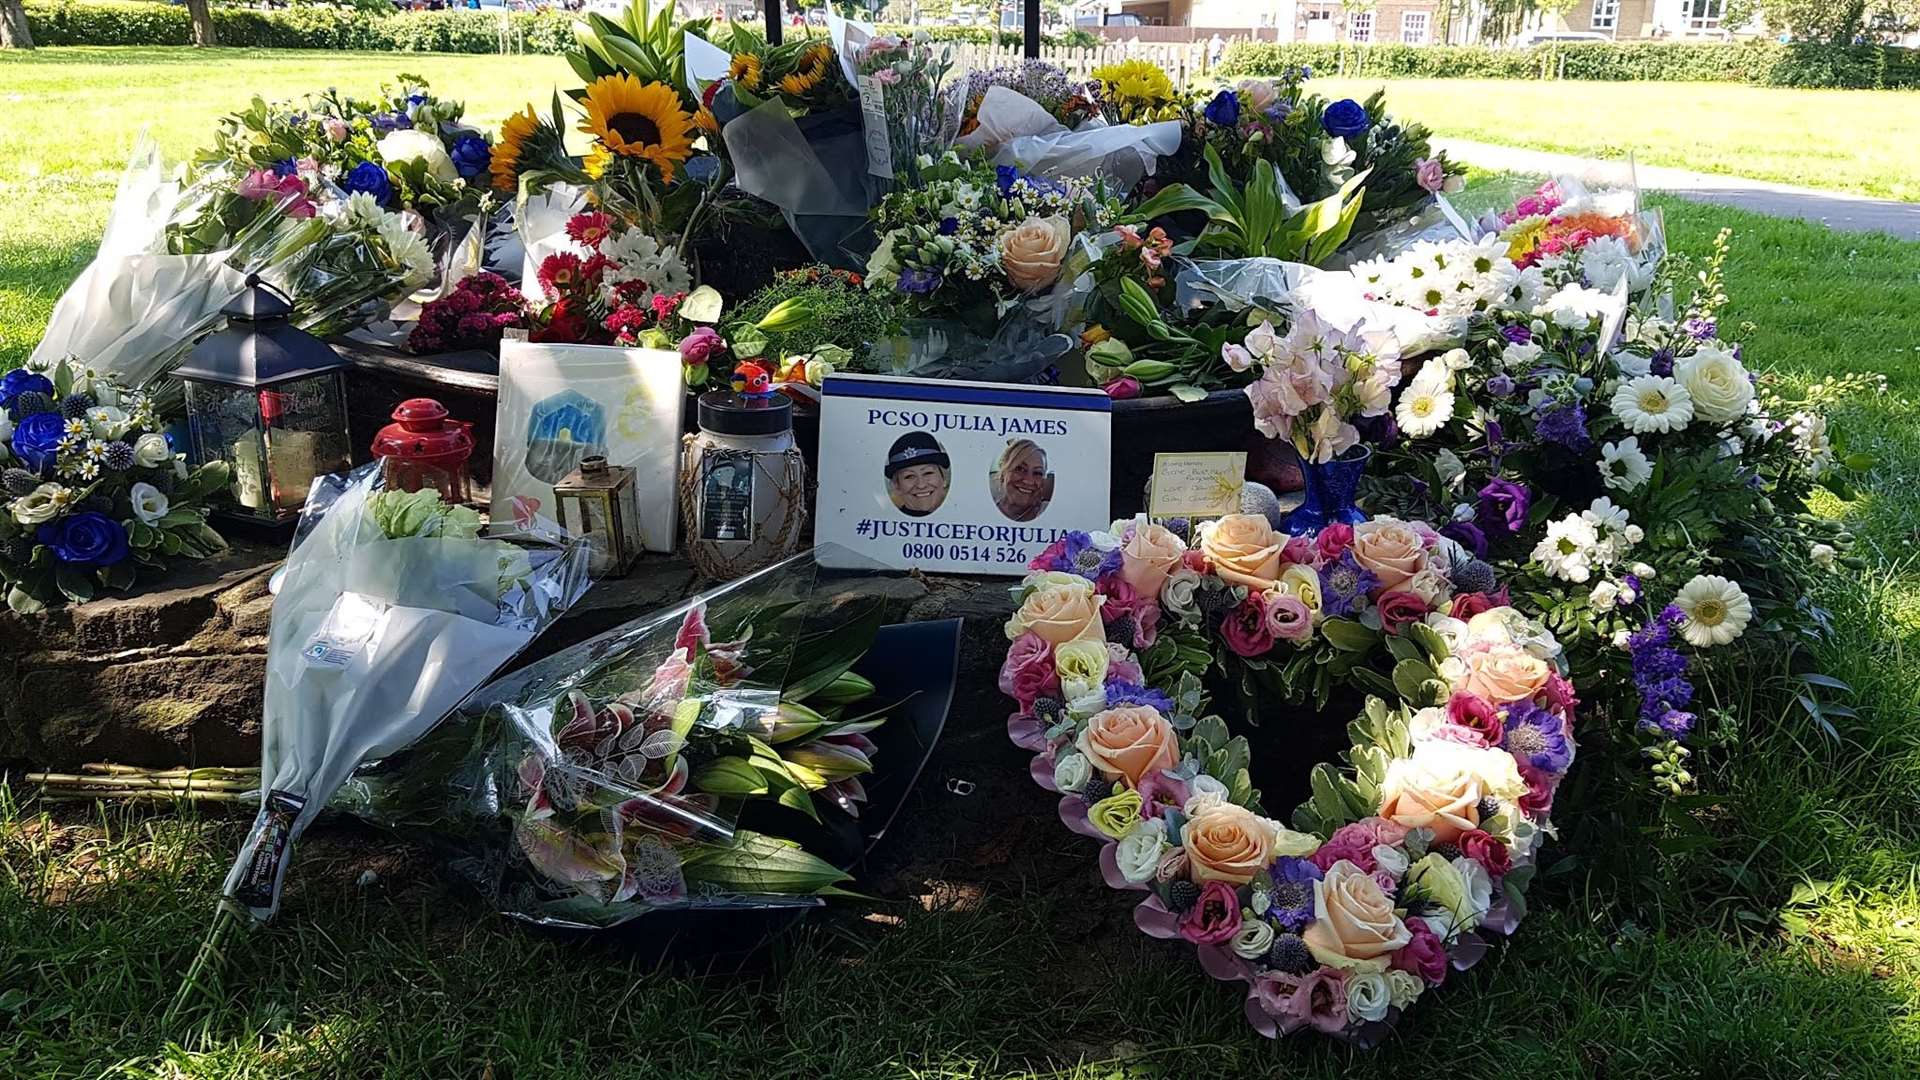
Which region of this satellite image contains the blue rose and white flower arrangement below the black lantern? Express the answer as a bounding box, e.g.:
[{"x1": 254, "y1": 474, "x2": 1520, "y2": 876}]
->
[{"x1": 0, "y1": 361, "x2": 227, "y2": 613}]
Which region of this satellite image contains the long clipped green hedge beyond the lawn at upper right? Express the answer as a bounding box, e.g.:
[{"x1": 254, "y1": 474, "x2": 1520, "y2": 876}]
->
[{"x1": 1221, "y1": 42, "x2": 1920, "y2": 90}]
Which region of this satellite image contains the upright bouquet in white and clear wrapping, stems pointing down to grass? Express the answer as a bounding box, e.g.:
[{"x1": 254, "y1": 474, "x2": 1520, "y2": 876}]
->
[{"x1": 223, "y1": 465, "x2": 588, "y2": 920}]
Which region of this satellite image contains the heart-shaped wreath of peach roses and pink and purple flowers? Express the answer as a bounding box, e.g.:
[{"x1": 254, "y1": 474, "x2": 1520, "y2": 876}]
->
[{"x1": 1000, "y1": 515, "x2": 1576, "y2": 1045}]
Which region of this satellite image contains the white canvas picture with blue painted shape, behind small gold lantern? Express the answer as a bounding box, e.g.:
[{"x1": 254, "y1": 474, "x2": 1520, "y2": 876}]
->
[{"x1": 493, "y1": 340, "x2": 685, "y2": 552}]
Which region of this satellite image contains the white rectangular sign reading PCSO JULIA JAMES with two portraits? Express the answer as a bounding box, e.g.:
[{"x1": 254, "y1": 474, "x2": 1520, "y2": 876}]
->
[{"x1": 816, "y1": 375, "x2": 1114, "y2": 577}]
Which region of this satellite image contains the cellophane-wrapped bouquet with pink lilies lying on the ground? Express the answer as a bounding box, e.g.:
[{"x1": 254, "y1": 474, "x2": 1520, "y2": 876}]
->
[{"x1": 336, "y1": 553, "x2": 906, "y2": 928}]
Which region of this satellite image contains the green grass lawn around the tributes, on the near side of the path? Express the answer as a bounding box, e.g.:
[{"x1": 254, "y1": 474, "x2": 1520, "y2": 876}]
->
[{"x1": 11, "y1": 50, "x2": 1920, "y2": 1080}]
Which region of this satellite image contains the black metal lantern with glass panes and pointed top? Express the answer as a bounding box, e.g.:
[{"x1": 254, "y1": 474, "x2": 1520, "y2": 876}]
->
[{"x1": 175, "y1": 275, "x2": 353, "y2": 523}]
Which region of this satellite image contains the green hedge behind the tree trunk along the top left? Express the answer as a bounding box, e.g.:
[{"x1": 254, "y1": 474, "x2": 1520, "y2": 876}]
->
[{"x1": 27, "y1": 0, "x2": 1083, "y2": 52}]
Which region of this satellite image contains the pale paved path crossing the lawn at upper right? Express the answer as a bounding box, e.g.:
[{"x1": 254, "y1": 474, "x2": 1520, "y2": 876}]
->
[{"x1": 1432, "y1": 138, "x2": 1920, "y2": 240}]
